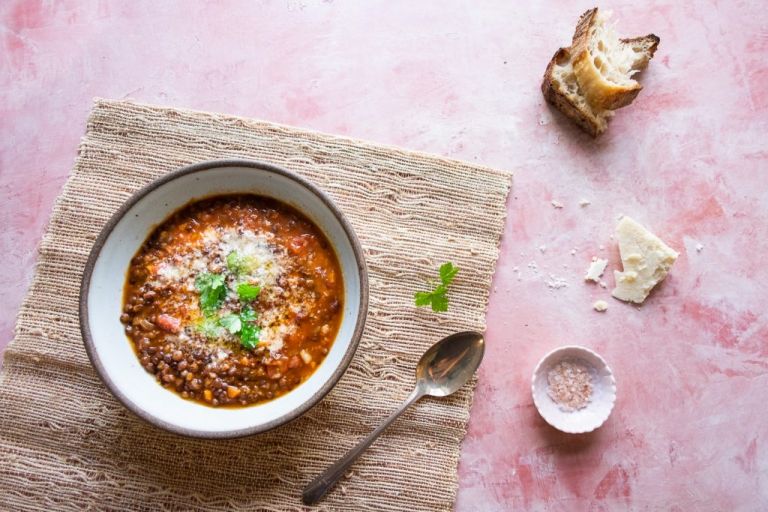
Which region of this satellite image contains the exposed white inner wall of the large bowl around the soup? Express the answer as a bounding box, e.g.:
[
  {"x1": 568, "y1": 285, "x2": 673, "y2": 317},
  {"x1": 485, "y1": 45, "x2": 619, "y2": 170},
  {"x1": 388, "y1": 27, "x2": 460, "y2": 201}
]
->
[{"x1": 87, "y1": 166, "x2": 361, "y2": 435}]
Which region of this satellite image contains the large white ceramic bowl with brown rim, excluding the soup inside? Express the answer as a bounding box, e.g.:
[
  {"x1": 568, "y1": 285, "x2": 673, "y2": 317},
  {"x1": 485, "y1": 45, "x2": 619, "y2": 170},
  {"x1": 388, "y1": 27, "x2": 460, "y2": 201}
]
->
[{"x1": 80, "y1": 160, "x2": 368, "y2": 438}]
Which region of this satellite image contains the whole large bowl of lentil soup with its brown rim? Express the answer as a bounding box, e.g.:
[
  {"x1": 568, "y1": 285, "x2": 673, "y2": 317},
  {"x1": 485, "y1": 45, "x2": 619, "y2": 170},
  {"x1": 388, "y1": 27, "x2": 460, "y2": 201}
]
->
[{"x1": 80, "y1": 160, "x2": 368, "y2": 438}]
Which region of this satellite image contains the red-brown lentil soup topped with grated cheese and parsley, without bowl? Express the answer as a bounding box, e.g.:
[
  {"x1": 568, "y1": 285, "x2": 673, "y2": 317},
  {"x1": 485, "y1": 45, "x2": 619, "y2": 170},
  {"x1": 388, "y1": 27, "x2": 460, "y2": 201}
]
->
[{"x1": 120, "y1": 195, "x2": 344, "y2": 406}]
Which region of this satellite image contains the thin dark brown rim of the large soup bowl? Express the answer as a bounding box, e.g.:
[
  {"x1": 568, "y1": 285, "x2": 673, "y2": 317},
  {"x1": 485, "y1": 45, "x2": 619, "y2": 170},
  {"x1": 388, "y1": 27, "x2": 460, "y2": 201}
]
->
[{"x1": 79, "y1": 159, "x2": 368, "y2": 439}]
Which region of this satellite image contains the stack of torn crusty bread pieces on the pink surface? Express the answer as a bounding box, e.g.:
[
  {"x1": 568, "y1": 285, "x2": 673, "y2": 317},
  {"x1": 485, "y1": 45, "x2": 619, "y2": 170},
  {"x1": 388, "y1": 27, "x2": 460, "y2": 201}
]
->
[{"x1": 541, "y1": 8, "x2": 659, "y2": 137}]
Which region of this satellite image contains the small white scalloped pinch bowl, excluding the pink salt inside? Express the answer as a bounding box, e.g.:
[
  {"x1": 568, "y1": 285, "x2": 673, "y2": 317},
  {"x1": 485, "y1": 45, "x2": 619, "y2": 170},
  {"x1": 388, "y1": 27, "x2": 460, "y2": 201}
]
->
[{"x1": 531, "y1": 345, "x2": 616, "y2": 434}]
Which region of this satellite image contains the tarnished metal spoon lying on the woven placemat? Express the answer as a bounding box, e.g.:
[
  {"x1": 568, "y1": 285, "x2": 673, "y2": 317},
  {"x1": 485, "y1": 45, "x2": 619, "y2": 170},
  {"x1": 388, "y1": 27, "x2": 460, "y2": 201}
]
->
[{"x1": 302, "y1": 331, "x2": 485, "y2": 505}]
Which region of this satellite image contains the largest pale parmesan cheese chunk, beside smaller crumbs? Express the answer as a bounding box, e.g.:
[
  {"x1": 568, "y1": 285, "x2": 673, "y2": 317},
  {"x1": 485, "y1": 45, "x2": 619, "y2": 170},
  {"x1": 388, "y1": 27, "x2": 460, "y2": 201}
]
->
[{"x1": 613, "y1": 217, "x2": 678, "y2": 304}]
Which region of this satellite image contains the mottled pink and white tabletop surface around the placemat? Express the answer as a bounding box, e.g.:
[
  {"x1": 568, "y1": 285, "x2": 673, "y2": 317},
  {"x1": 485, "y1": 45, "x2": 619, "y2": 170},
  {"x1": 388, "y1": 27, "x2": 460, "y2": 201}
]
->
[{"x1": 0, "y1": 0, "x2": 768, "y2": 511}]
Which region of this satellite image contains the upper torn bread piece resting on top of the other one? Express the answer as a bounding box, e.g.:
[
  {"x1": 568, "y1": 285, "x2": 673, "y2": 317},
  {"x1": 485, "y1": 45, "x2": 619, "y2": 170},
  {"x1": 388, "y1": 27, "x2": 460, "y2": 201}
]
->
[{"x1": 571, "y1": 8, "x2": 658, "y2": 110}]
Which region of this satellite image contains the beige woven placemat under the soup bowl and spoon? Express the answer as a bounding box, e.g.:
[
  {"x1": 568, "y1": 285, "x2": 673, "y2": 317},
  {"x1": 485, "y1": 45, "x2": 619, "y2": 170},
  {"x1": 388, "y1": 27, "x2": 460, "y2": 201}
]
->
[{"x1": 0, "y1": 100, "x2": 511, "y2": 511}]
